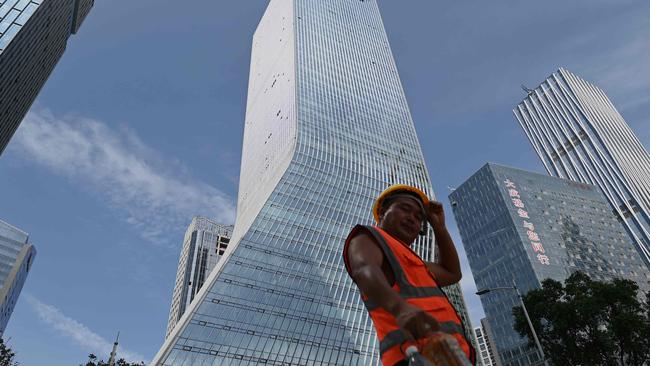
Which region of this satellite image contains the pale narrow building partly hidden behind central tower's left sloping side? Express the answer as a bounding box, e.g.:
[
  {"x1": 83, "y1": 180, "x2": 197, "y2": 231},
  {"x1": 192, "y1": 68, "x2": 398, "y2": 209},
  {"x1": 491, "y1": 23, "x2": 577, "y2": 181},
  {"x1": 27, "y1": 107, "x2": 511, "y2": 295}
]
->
[{"x1": 165, "y1": 216, "x2": 232, "y2": 338}]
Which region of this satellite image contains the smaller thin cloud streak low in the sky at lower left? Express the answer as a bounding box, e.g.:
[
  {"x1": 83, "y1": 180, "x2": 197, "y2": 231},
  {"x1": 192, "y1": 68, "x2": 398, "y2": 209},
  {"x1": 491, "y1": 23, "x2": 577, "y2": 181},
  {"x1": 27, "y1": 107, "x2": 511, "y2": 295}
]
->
[{"x1": 25, "y1": 294, "x2": 145, "y2": 362}]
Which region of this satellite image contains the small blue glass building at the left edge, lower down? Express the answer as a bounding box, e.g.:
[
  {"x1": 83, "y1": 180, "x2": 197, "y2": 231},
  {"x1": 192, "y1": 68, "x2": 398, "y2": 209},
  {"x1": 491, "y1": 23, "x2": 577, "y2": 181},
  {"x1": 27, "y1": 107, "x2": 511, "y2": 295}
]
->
[{"x1": 0, "y1": 220, "x2": 36, "y2": 336}]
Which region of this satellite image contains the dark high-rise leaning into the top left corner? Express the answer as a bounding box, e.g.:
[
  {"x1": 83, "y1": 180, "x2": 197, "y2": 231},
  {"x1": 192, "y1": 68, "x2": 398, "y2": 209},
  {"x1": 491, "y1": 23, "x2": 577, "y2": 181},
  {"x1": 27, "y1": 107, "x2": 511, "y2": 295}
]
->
[{"x1": 0, "y1": 0, "x2": 94, "y2": 154}]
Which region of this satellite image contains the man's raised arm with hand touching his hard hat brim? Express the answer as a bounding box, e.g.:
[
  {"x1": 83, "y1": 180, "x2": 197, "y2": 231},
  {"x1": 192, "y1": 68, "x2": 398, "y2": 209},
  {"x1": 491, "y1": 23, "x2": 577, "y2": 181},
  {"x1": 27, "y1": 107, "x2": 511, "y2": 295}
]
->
[{"x1": 426, "y1": 201, "x2": 463, "y2": 286}]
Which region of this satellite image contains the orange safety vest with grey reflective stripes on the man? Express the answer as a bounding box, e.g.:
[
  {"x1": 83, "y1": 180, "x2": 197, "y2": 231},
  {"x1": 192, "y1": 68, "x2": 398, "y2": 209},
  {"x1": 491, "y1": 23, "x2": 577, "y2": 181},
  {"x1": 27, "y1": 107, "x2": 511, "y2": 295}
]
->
[{"x1": 343, "y1": 225, "x2": 476, "y2": 366}]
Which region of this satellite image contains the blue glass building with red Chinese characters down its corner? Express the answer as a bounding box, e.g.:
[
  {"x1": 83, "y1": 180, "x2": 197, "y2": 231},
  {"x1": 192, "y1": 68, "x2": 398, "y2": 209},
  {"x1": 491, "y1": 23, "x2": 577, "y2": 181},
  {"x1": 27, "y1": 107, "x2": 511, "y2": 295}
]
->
[{"x1": 449, "y1": 164, "x2": 650, "y2": 366}]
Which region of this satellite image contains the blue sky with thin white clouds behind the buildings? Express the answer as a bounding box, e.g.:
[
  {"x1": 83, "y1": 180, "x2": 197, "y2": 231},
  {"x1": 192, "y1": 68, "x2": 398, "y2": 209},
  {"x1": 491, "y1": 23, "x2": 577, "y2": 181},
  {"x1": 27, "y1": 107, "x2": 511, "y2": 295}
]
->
[{"x1": 0, "y1": 0, "x2": 650, "y2": 366}]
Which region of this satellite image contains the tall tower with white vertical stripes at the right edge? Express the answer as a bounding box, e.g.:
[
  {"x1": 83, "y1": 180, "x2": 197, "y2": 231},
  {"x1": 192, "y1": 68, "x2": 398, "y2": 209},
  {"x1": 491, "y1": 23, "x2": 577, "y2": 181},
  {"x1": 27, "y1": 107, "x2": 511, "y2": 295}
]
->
[{"x1": 514, "y1": 68, "x2": 650, "y2": 266}]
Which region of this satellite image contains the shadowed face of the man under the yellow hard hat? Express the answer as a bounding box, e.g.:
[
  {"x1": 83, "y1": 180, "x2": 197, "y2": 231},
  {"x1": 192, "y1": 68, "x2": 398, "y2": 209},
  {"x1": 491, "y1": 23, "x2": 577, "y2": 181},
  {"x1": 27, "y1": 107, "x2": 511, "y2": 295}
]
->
[{"x1": 379, "y1": 196, "x2": 425, "y2": 245}]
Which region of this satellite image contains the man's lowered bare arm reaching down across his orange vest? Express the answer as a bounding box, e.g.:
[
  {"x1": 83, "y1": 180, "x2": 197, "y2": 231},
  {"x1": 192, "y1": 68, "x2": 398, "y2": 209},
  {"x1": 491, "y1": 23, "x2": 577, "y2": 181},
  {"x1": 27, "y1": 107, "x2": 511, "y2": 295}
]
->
[{"x1": 347, "y1": 234, "x2": 438, "y2": 339}]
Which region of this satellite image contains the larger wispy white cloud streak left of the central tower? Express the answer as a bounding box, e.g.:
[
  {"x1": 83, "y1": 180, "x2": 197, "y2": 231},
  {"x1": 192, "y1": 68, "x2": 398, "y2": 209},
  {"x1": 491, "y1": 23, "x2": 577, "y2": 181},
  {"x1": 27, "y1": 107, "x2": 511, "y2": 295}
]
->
[{"x1": 13, "y1": 110, "x2": 235, "y2": 246}]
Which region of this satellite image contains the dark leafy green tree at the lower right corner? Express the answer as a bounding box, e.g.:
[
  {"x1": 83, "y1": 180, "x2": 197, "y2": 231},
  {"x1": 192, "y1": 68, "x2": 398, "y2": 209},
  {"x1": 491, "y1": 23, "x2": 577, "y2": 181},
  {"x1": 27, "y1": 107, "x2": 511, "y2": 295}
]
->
[{"x1": 513, "y1": 272, "x2": 650, "y2": 366}]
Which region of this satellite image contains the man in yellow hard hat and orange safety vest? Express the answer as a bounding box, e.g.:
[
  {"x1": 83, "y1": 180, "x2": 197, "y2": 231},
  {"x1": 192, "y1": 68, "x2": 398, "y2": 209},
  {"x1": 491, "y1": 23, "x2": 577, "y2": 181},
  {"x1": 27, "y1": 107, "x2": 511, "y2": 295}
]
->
[{"x1": 343, "y1": 184, "x2": 475, "y2": 366}]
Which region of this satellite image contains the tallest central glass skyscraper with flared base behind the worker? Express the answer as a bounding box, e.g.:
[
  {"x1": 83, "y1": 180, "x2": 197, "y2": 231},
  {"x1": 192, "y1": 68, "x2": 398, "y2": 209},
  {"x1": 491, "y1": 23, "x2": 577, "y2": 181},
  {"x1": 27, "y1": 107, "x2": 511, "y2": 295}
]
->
[{"x1": 153, "y1": 0, "x2": 471, "y2": 366}]
